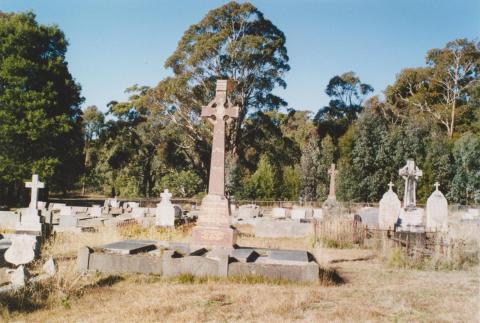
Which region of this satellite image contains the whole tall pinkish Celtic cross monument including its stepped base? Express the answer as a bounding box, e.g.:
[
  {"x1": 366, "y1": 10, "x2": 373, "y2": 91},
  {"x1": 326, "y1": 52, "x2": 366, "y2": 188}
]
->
[{"x1": 191, "y1": 80, "x2": 238, "y2": 248}]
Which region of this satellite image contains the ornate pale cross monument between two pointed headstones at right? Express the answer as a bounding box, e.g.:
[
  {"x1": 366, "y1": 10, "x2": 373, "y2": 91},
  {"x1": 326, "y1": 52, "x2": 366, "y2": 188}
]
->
[{"x1": 397, "y1": 159, "x2": 425, "y2": 232}]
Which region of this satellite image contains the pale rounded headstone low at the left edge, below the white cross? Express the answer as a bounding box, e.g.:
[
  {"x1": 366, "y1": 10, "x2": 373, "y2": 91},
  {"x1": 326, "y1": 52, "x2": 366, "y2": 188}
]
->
[{"x1": 5, "y1": 234, "x2": 37, "y2": 266}]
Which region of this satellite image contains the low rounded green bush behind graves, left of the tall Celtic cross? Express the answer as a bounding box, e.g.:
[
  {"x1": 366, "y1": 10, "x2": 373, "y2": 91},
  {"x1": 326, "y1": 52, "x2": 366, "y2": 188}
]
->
[{"x1": 155, "y1": 170, "x2": 203, "y2": 197}]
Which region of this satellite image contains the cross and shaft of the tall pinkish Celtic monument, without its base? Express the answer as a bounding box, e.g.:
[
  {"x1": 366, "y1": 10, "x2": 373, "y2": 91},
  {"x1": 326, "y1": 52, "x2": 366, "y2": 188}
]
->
[{"x1": 202, "y1": 80, "x2": 239, "y2": 196}]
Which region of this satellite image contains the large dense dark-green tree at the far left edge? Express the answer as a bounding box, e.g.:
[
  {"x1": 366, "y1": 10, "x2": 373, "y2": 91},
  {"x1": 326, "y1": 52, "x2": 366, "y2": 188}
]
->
[{"x1": 0, "y1": 13, "x2": 83, "y2": 203}]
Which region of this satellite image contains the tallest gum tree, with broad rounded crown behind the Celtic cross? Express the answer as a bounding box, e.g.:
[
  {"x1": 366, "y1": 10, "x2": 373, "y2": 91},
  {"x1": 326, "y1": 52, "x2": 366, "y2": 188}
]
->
[{"x1": 152, "y1": 2, "x2": 290, "y2": 167}]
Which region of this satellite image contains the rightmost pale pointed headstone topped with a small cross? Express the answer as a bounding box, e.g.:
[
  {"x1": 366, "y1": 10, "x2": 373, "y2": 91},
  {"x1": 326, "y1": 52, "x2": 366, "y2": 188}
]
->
[{"x1": 426, "y1": 182, "x2": 448, "y2": 232}]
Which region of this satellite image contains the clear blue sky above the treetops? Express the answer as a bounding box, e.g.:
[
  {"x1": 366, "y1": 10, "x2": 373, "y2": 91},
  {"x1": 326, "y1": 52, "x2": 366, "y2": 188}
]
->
[{"x1": 0, "y1": 0, "x2": 480, "y2": 111}]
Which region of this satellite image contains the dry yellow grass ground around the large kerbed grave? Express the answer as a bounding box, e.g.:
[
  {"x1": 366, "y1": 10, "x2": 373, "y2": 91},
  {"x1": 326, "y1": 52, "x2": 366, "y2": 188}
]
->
[{"x1": 0, "y1": 225, "x2": 480, "y2": 322}]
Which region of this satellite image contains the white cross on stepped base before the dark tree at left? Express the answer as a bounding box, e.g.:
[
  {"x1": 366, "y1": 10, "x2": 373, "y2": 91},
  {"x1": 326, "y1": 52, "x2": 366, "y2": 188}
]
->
[{"x1": 15, "y1": 174, "x2": 45, "y2": 235}]
